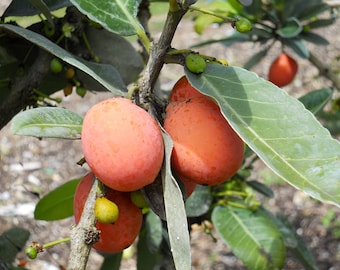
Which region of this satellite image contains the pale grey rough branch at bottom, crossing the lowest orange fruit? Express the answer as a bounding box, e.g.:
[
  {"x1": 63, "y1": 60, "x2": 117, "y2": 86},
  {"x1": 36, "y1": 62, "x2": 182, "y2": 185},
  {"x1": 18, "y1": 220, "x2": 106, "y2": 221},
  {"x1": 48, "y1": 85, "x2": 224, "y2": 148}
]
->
[{"x1": 67, "y1": 176, "x2": 98, "y2": 270}]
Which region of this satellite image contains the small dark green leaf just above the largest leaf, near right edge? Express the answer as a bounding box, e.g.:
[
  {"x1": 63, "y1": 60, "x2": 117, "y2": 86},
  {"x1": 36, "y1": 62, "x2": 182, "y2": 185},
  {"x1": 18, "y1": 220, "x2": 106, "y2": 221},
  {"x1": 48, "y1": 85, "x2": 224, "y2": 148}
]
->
[{"x1": 299, "y1": 88, "x2": 333, "y2": 114}]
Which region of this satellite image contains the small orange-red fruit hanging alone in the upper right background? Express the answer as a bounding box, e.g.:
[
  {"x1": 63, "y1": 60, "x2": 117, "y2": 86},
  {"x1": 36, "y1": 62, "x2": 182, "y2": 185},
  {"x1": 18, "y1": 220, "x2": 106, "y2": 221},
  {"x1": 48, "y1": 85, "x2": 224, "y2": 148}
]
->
[{"x1": 268, "y1": 53, "x2": 298, "y2": 87}]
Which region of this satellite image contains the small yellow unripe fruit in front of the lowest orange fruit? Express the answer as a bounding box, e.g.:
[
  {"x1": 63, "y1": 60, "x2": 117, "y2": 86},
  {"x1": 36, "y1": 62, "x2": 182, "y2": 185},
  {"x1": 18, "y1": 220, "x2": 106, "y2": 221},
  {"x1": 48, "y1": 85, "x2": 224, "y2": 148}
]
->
[{"x1": 94, "y1": 197, "x2": 119, "y2": 224}]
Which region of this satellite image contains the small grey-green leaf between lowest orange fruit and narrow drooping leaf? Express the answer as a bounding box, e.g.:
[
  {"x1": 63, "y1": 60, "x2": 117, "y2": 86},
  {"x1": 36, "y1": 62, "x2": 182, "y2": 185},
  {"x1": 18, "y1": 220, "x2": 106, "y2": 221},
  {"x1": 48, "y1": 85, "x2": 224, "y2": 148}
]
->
[{"x1": 145, "y1": 211, "x2": 163, "y2": 253}]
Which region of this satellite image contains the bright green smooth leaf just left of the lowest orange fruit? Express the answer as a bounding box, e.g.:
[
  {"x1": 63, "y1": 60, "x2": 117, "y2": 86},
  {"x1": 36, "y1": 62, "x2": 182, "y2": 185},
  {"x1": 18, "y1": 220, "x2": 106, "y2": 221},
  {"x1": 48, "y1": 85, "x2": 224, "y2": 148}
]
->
[{"x1": 34, "y1": 179, "x2": 80, "y2": 221}]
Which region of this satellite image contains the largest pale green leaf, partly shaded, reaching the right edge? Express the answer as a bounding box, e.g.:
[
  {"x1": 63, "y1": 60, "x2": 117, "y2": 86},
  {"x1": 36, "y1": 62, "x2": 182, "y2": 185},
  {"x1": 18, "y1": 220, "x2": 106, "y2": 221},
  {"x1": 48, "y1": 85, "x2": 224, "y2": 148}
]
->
[{"x1": 186, "y1": 65, "x2": 340, "y2": 206}]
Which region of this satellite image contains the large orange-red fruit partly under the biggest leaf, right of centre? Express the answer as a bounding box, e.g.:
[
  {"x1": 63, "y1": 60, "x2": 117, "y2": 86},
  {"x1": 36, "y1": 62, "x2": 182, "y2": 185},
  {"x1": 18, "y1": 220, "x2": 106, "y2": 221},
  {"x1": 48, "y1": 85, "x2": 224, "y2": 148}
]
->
[{"x1": 164, "y1": 97, "x2": 244, "y2": 185}]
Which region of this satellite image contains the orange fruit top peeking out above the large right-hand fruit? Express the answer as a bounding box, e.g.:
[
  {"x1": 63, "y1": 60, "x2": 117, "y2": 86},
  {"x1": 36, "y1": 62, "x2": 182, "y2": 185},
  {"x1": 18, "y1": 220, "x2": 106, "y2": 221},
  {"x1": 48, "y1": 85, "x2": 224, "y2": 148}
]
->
[{"x1": 169, "y1": 76, "x2": 204, "y2": 102}]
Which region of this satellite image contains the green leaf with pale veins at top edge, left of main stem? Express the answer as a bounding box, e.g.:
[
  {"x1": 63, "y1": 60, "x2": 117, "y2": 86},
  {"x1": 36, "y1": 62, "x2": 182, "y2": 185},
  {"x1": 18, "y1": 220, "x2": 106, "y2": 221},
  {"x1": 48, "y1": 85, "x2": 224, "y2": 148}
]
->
[{"x1": 71, "y1": 0, "x2": 142, "y2": 36}]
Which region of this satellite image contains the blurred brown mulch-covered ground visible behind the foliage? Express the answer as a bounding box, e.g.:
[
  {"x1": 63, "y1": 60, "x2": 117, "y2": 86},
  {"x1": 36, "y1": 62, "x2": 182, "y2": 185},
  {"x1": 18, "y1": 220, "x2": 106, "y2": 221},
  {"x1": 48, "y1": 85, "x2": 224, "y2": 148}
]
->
[{"x1": 0, "y1": 4, "x2": 340, "y2": 270}]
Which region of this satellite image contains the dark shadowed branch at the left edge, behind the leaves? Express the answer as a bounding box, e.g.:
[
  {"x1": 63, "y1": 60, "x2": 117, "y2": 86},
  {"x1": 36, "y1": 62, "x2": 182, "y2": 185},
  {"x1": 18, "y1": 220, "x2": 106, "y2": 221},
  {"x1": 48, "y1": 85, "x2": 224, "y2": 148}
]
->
[{"x1": 0, "y1": 49, "x2": 52, "y2": 129}]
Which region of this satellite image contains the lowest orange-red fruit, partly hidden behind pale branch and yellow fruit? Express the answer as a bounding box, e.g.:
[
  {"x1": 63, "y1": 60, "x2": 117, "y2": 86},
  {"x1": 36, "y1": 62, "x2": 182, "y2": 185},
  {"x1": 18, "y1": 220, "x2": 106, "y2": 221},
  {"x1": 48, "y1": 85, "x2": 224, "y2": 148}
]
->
[{"x1": 73, "y1": 173, "x2": 143, "y2": 253}]
